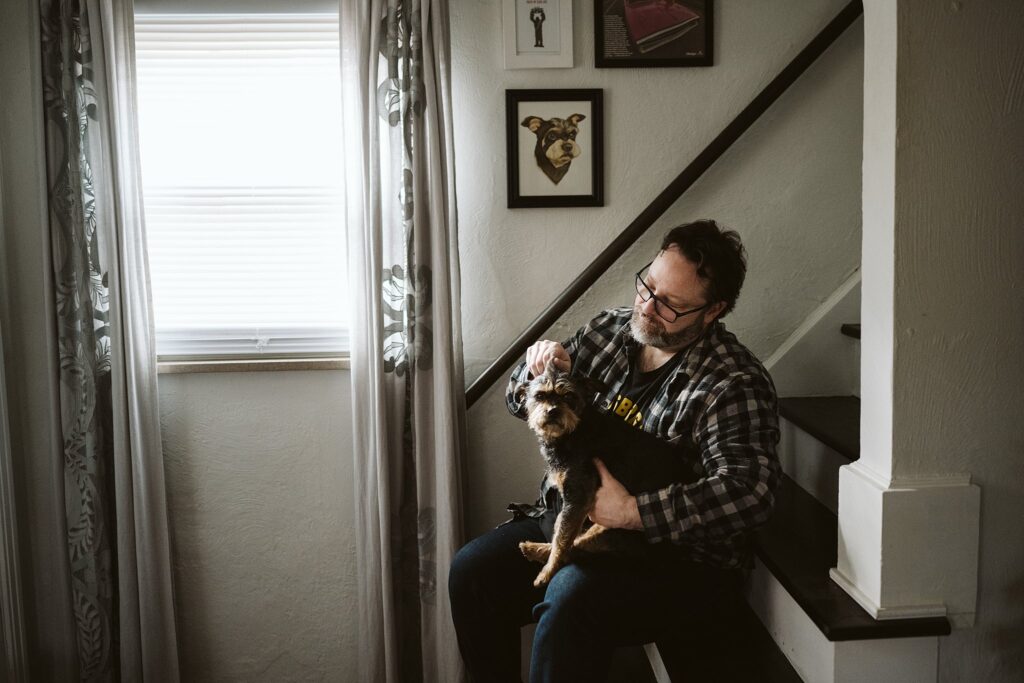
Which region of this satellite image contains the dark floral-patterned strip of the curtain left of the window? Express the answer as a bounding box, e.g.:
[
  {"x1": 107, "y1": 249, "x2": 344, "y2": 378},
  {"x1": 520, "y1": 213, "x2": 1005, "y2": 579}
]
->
[{"x1": 41, "y1": 2, "x2": 118, "y2": 681}]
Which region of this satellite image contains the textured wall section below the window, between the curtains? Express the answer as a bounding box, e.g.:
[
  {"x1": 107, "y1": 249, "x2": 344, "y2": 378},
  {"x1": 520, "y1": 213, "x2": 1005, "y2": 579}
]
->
[{"x1": 160, "y1": 371, "x2": 357, "y2": 683}]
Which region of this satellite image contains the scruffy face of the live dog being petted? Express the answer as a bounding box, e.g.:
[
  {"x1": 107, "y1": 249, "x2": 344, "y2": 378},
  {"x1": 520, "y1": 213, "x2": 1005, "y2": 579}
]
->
[{"x1": 518, "y1": 362, "x2": 603, "y2": 441}]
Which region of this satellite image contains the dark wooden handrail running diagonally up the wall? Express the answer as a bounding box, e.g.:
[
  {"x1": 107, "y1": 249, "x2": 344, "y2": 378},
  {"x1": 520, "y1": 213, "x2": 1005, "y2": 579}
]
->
[{"x1": 466, "y1": 0, "x2": 863, "y2": 408}]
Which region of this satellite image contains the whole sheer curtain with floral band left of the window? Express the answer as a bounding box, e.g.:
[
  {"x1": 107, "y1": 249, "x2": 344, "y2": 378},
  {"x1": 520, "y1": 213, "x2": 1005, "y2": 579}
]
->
[{"x1": 40, "y1": 0, "x2": 178, "y2": 681}]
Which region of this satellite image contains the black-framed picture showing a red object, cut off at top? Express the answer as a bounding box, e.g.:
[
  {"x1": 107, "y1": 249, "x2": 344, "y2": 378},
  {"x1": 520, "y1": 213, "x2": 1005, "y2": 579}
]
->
[{"x1": 594, "y1": 0, "x2": 714, "y2": 68}]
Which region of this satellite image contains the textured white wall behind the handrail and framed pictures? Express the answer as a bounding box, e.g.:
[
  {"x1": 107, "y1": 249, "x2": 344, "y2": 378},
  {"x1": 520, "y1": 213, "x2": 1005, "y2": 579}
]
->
[{"x1": 453, "y1": 0, "x2": 863, "y2": 533}]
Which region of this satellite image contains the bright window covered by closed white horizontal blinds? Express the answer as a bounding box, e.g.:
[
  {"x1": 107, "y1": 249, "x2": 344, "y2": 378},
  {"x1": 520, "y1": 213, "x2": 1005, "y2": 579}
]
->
[{"x1": 135, "y1": 7, "x2": 347, "y2": 359}]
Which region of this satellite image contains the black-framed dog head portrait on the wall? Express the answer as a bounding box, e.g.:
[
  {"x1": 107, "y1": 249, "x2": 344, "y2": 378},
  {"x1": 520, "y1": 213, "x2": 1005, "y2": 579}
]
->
[{"x1": 505, "y1": 90, "x2": 604, "y2": 209}]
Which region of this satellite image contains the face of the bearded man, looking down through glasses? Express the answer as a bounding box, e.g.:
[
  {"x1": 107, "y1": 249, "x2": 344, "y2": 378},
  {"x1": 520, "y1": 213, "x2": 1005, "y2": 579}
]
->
[{"x1": 630, "y1": 247, "x2": 725, "y2": 350}]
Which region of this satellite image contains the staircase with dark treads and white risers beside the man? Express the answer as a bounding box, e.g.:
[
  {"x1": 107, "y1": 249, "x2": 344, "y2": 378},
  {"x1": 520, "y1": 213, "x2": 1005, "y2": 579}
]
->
[{"x1": 733, "y1": 316, "x2": 950, "y2": 683}]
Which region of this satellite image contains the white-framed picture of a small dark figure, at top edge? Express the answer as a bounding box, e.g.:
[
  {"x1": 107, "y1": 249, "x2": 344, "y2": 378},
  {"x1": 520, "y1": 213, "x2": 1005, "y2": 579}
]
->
[{"x1": 501, "y1": 0, "x2": 572, "y2": 69}]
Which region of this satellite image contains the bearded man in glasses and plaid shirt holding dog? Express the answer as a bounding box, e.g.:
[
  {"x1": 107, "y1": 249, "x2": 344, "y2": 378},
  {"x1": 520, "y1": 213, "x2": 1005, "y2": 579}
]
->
[{"x1": 449, "y1": 221, "x2": 780, "y2": 682}]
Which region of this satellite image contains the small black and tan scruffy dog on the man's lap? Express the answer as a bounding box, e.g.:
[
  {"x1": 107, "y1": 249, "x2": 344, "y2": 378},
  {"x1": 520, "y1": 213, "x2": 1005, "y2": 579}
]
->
[{"x1": 517, "y1": 362, "x2": 699, "y2": 586}]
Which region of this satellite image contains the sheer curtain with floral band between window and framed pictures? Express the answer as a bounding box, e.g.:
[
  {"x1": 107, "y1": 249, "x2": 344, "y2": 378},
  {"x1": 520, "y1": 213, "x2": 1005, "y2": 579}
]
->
[{"x1": 341, "y1": 0, "x2": 465, "y2": 683}]
